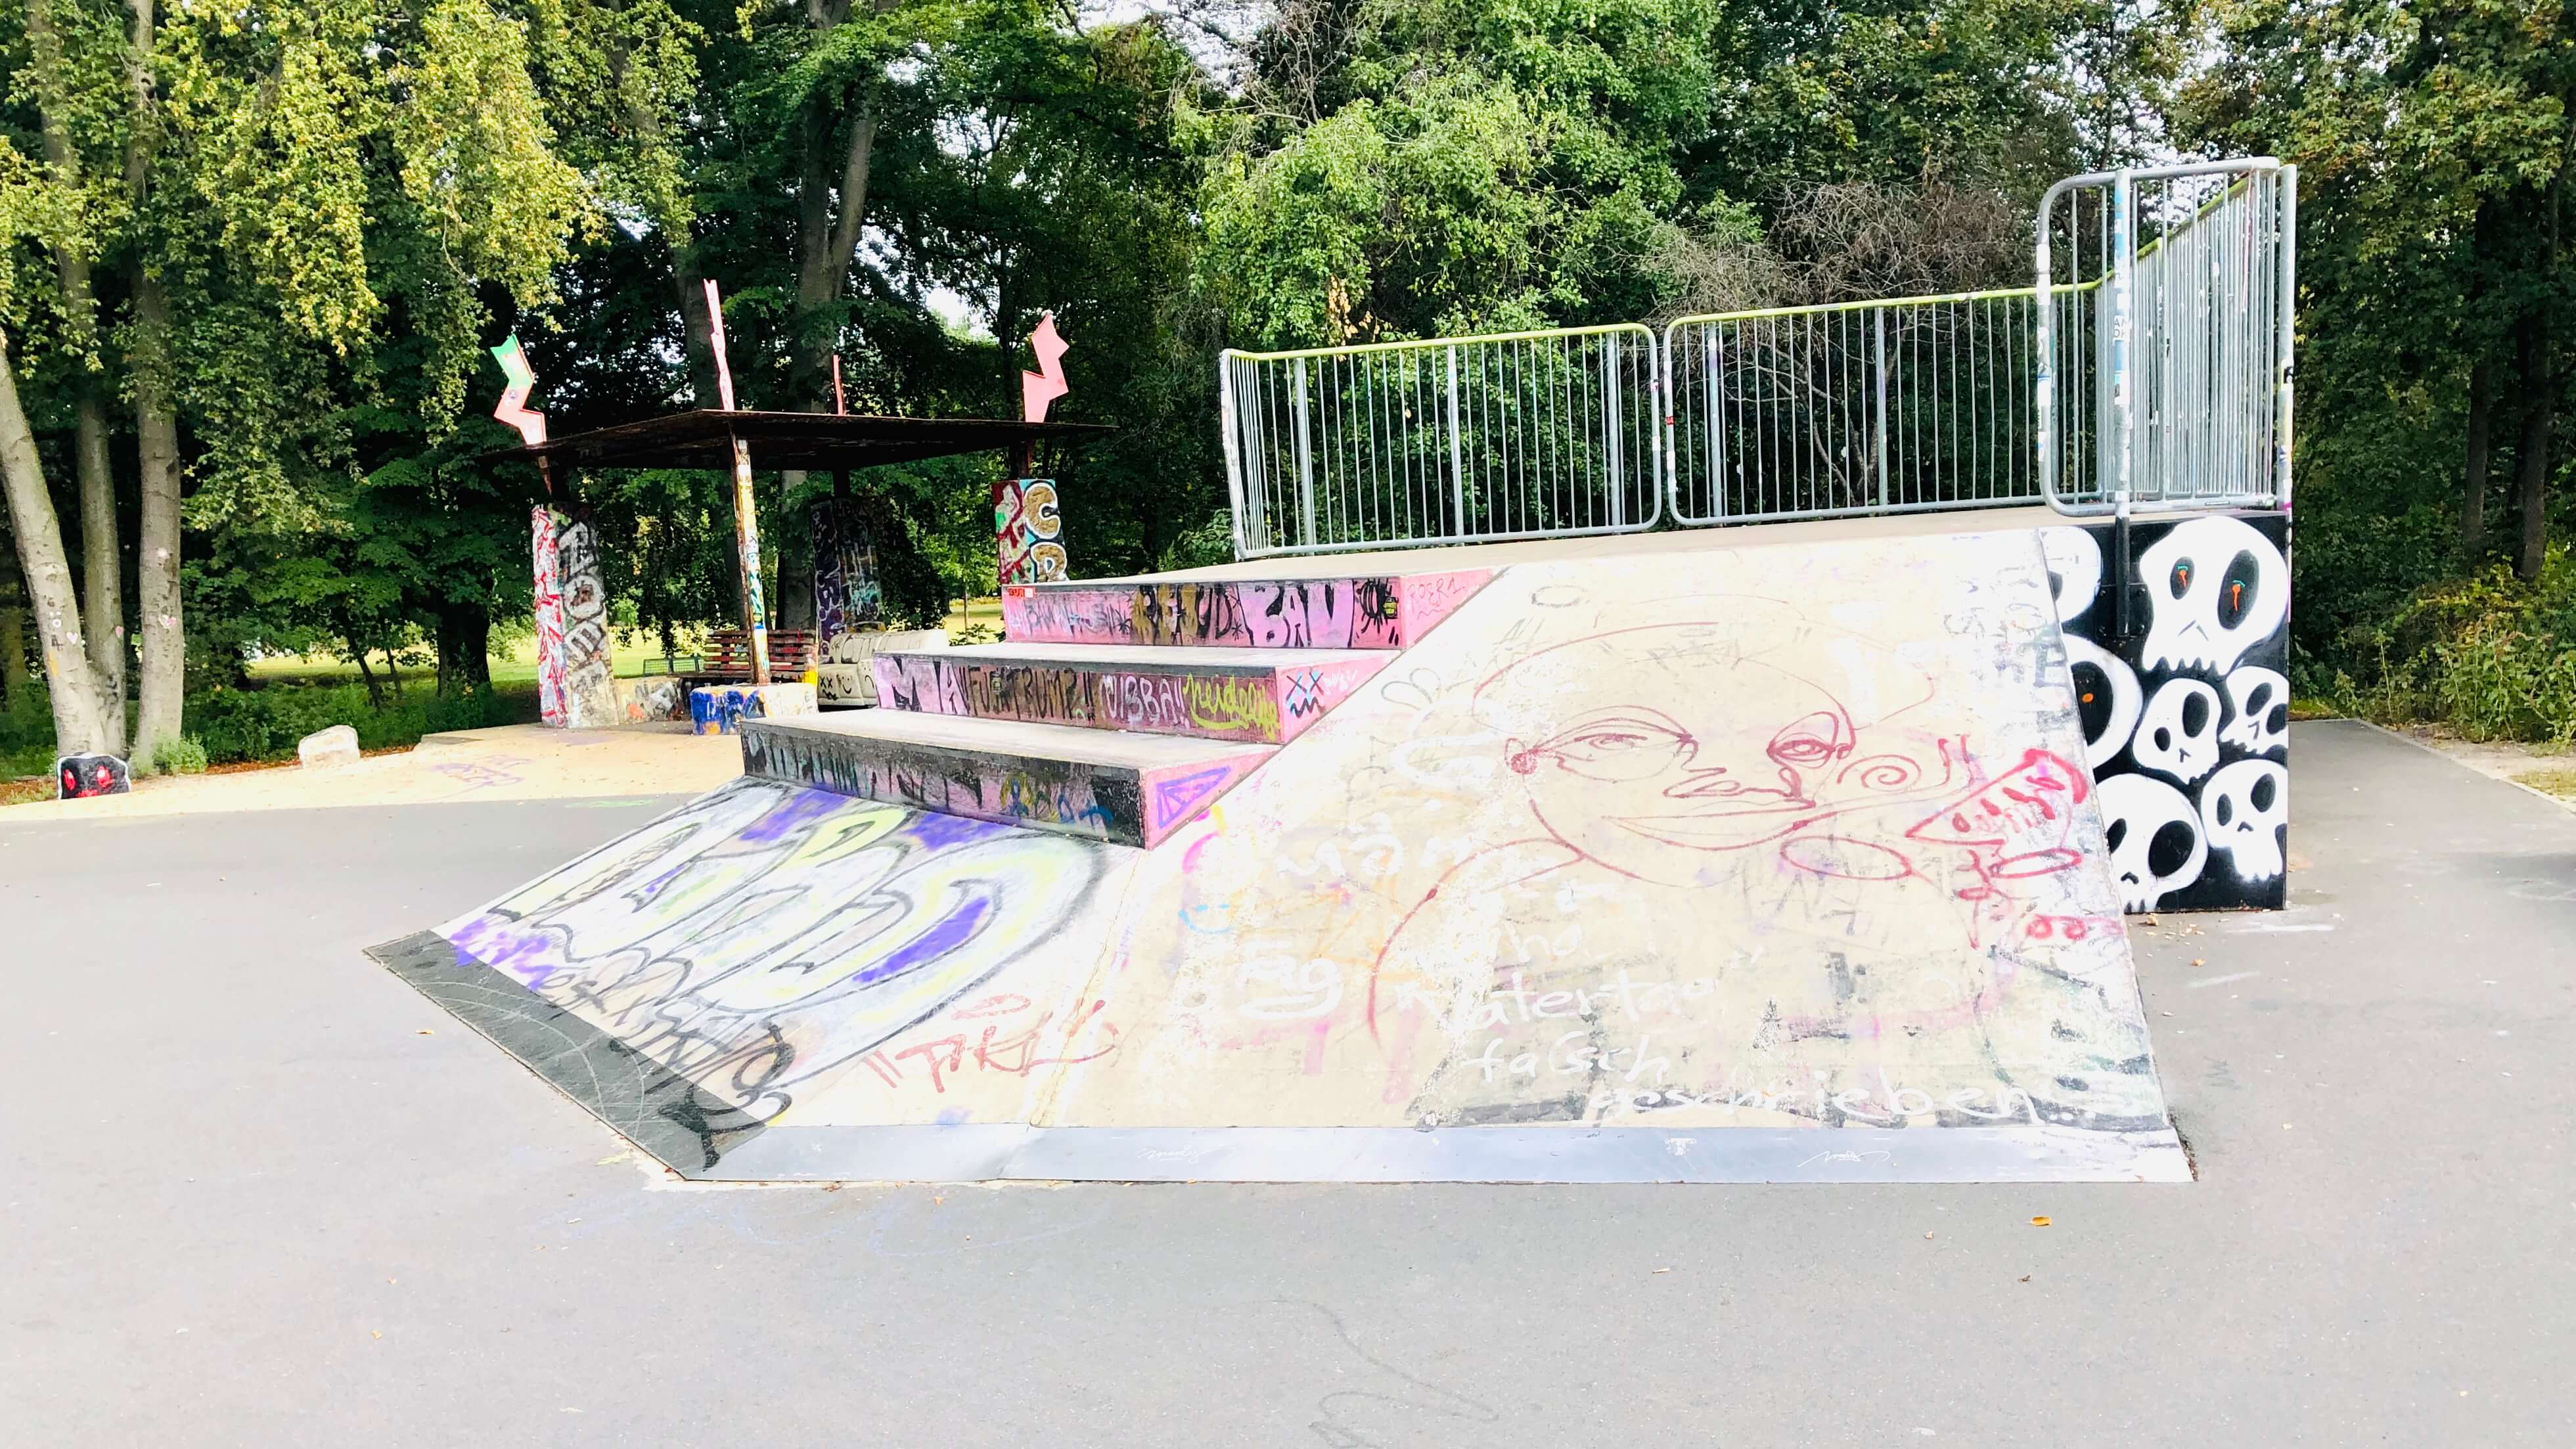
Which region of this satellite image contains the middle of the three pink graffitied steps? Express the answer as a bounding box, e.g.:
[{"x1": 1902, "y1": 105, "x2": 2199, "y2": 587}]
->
[{"x1": 870, "y1": 644, "x2": 1393, "y2": 744}]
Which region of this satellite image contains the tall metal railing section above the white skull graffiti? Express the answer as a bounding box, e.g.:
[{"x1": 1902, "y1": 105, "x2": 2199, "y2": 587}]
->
[{"x1": 2035, "y1": 157, "x2": 2298, "y2": 515}]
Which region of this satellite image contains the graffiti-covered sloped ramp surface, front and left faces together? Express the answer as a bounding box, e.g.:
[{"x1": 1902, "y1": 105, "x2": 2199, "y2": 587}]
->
[{"x1": 378, "y1": 530, "x2": 2187, "y2": 1181}]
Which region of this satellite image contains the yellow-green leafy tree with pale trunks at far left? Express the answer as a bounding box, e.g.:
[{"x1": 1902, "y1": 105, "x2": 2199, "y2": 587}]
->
[{"x1": 0, "y1": 0, "x2": 690, "y2": 757}]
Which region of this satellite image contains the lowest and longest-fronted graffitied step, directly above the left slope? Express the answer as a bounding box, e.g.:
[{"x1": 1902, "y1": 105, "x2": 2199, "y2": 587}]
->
[{"x1": 742, "y1": 708, "x2": 1278, "y2": 847}]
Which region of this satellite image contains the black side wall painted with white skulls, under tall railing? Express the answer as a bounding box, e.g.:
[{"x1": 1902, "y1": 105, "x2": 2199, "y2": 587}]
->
[{"x1": 2043, "y1": 515, "x2": 2290, "y2": 911}]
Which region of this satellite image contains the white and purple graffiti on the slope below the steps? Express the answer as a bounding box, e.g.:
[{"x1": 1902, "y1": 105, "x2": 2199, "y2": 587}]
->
[{"x1": 445, "y1": 780, "x2": 1108, "y2": 1158}]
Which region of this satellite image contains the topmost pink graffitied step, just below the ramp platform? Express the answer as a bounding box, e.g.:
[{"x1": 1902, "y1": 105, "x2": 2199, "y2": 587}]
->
[{"x1": 1002, "y1": 569, "x2": 1494, "y2": 648}]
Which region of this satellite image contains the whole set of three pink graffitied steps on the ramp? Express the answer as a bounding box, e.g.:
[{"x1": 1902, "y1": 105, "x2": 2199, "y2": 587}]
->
[{"x1": 742, "y1": 569, "x2": 1494, "y2": 847}]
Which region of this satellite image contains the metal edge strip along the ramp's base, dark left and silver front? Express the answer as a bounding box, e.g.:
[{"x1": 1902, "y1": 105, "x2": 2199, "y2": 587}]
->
[{"x1": 366, "y1": 931, "x2": 2192, "y2": 1184}]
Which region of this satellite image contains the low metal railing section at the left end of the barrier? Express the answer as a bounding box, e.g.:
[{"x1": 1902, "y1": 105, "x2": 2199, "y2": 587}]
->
[{"x1": 1219, "y1": 322, "x2": 1664, "y2": 558}]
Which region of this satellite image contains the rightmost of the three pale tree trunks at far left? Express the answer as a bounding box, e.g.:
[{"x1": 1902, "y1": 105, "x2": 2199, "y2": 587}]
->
[{"x1": 131, "y1": 265, "x2": 188, "y2": 759}]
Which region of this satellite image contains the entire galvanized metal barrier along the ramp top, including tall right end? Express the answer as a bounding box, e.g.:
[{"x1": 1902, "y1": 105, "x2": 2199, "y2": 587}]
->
[{"x1": 1219, "y1": 157, "x2": 2298, "y2": 558}]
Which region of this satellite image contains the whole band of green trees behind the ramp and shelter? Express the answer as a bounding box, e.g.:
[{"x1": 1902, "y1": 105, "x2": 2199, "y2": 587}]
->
[{"x1": 0, "y1": 0, "x2": 2576, "y2": 757}]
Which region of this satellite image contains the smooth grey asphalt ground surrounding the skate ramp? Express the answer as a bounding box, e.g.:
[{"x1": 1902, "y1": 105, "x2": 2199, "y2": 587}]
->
[{"x1": 0, "y1": 723, "x2": 2576, "y2": 1449}]
